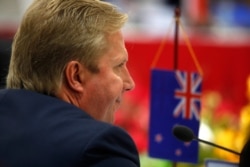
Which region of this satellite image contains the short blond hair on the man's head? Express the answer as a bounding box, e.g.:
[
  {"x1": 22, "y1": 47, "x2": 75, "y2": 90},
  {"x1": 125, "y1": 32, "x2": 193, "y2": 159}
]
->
[{"x1": 7, "y1": 0, "x2": 127, "y2": 94}]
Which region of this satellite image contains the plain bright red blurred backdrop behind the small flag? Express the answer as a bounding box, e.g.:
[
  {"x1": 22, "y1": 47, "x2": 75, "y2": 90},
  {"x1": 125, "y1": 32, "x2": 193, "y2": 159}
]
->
[{"x1": 126, "y1": 38, "x2": 250, "y2": 115}]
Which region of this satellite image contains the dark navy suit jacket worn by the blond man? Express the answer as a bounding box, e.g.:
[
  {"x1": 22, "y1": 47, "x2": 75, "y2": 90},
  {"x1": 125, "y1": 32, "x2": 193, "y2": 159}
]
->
[{"x1": 0, "y1": 89, "x2": 140, "y2": 167}]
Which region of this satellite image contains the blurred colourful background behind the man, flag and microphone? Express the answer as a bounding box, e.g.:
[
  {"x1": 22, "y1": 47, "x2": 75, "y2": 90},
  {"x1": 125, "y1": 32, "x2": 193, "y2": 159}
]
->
[{"x1": 0, "y1": 0, "x2": 250, "y2": 167}]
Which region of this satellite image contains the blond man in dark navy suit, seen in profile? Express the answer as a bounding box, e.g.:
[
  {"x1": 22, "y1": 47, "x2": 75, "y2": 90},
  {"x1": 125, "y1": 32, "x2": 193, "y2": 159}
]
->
[{"x1": 0, "y1": 0, "x2": 140, "y2": 167}]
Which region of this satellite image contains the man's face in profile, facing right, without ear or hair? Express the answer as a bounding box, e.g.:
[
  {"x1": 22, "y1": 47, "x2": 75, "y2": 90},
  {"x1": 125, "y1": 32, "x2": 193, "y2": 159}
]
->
[{"x1": 80, "y1": 32, "x2": 135, "y2": 123}]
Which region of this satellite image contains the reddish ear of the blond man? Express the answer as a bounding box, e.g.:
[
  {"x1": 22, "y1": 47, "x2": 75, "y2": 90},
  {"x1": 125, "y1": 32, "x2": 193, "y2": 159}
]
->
[{"x1": 64, "y1": 61, "x2": 84, "y2": 92}]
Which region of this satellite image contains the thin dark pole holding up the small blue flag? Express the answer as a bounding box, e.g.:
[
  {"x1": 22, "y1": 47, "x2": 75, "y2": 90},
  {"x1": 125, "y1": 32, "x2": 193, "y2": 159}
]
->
[{"x1": 173, "y1": 7, "x2": 180, "y2": 167}]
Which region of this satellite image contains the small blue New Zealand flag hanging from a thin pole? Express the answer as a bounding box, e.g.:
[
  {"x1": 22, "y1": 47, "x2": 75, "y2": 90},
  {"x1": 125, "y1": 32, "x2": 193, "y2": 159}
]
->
[{"x1": 149, "y1": 69, "x2": 202, "y2": 163}]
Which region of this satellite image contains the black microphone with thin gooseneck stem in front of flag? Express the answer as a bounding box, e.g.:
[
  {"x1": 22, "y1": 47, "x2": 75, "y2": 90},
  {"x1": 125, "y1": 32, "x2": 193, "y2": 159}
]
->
[{"x1": 172, "y1": 125, "x2": 240, "y2": 155}]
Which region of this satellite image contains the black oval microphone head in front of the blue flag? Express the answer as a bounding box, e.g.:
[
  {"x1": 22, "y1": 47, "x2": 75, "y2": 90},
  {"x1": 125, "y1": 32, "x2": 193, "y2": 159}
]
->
[{"x1": 172, "y1": 125, "x2": 195, "y2": 142}]
